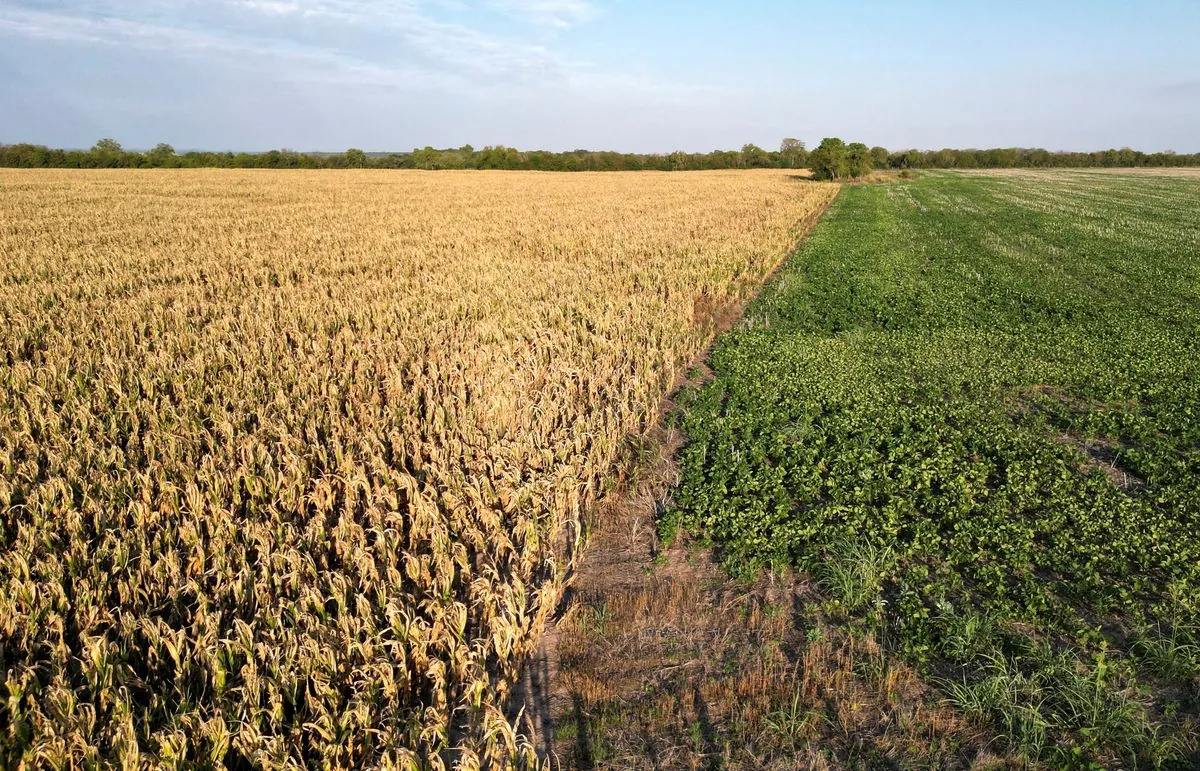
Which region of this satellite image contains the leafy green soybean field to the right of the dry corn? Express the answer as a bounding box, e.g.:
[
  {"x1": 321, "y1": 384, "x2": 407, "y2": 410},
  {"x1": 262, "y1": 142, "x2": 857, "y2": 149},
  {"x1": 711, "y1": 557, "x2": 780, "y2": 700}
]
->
[{"x1": 659, "y1": 172, "x2": 1200, "y2": 767}]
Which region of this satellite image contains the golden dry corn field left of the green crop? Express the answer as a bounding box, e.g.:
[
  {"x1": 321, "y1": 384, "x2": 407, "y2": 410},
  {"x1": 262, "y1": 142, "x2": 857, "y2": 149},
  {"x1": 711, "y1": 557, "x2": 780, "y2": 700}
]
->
[{"x1": 0, "y1": 171, "x2": 836, "y2": 769}]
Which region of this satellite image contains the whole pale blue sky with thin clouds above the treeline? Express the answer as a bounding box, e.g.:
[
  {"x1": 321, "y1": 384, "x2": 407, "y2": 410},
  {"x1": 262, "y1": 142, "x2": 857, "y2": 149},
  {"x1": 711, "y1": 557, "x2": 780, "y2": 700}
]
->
[{"x1": 0, "y1": 0, "x2": 1200, "y2": 153}]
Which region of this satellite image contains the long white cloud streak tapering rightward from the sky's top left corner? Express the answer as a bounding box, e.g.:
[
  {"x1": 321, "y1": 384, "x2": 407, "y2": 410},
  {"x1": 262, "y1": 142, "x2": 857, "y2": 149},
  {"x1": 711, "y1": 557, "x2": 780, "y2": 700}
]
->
[{"x1": 0, "y1": 0, "x2": 568, "y2": 89}]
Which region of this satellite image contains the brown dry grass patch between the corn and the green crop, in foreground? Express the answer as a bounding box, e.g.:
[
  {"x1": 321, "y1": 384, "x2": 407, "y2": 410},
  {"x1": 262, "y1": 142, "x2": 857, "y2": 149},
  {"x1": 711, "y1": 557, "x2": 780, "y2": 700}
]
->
[{"x1": 539, "y1": 422, "x2": 1027, "y2": 770}]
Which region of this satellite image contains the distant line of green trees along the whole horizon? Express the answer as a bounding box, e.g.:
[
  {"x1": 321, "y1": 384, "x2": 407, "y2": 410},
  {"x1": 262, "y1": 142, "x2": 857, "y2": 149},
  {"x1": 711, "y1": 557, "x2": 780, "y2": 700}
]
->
[{"x1": 7, "y1": 138, "x2": 1200, "y2": 178}]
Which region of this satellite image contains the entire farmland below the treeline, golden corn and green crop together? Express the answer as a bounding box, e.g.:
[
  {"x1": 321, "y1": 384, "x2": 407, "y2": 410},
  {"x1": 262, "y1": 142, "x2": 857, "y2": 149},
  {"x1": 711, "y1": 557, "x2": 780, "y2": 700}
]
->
[{"x1": 0, "y1": 165, "x2": 1200, "y2": 769}]
